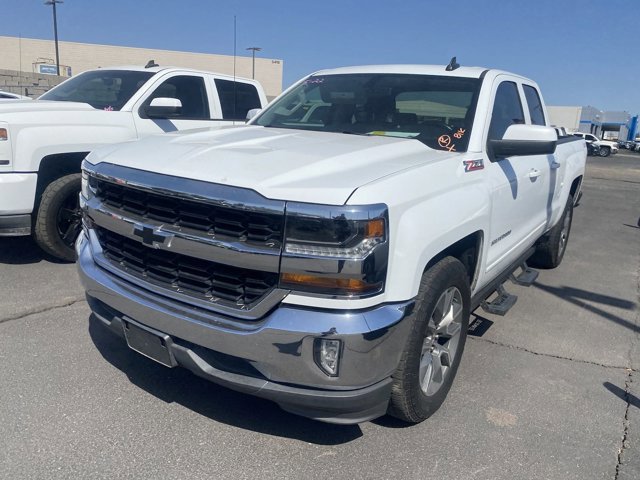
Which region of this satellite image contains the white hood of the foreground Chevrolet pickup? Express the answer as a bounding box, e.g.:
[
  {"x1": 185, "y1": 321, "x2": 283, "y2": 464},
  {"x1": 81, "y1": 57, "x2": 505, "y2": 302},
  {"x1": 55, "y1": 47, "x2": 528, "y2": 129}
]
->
[{"x1": 87, "y1": 126, "x2": 458, "y2": 205}]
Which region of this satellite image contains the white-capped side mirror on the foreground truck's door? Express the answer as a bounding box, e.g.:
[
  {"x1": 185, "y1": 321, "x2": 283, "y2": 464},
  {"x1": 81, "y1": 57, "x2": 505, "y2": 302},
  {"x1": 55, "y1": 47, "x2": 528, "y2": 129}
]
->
[{"x1": 489, "y1": 124, "x2": 558, "y2": 159}]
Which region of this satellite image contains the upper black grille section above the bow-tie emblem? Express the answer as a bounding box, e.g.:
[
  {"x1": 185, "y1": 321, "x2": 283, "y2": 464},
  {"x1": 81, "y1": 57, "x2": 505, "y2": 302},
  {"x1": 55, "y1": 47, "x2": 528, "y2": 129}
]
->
[{"x1": 92, "y1": 179, "x2": 284, "y2": 247}]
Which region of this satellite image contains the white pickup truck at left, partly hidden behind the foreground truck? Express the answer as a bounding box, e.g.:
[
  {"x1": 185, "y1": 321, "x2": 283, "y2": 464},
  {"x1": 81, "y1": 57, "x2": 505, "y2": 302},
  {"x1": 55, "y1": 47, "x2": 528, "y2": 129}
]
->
[{"x1": 0, "y1": 62, "x2": 267, "y2": 261}]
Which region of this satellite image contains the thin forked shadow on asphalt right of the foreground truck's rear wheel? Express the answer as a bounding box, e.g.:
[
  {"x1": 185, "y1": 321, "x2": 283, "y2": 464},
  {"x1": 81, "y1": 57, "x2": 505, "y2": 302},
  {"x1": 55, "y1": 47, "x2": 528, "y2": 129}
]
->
[{"x1": 534, "y1": 282, "x2": 640, "y2": 333}]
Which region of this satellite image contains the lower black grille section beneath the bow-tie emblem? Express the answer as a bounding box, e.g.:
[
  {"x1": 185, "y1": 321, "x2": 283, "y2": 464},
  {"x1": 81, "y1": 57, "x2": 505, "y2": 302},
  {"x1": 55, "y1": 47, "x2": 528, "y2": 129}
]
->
[{"x1": 96, "y1": 227, "x2": 278, "y2": 307}]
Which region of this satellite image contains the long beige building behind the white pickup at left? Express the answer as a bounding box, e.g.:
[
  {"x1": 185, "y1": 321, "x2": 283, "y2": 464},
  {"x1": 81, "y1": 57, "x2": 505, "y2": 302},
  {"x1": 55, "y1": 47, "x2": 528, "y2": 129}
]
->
[{"x1": 0, "y1": 36, "x2": 283, "y2": 100}]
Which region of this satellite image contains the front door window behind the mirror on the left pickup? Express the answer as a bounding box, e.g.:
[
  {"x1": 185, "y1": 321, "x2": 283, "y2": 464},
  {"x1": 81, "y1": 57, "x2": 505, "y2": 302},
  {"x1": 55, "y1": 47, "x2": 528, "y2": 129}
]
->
[{"x1": 144, "y1": 75, "x2": 211, "y2": 120}]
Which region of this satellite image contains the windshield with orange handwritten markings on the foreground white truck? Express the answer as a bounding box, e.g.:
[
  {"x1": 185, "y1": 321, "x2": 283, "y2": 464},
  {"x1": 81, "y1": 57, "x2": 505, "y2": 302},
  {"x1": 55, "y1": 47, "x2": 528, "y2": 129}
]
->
[{"x1": 255, "y1": 73, "x2": 480, "y2": 152}]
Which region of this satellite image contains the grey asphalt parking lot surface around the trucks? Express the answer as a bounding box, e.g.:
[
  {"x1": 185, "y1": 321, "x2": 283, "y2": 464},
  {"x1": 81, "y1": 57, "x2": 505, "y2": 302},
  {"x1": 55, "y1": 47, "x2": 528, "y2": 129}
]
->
[{"x1": 0, "y1": 150, "x2": 640, "y2": 480}]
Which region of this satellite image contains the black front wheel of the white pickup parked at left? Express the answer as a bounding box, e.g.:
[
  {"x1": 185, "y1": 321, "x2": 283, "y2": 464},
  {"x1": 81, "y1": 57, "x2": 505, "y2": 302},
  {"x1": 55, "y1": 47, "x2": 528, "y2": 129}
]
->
[{"x1": 34, "y1": 173, "x2": 82, "y2": 262}]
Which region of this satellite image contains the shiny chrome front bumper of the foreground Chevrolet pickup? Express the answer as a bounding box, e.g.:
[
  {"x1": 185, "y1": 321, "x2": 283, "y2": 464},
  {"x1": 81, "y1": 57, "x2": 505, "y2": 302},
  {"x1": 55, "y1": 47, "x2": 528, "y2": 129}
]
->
[{"x1": 77, "y1": 233, "x2": 413, "y2": 423}]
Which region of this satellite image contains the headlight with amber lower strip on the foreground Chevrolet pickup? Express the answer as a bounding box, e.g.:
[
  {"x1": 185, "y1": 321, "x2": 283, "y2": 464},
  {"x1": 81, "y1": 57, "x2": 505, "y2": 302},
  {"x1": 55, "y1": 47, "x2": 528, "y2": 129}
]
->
[{"x1": 280, "y1": 203, "x2": 389, "y2": 298}]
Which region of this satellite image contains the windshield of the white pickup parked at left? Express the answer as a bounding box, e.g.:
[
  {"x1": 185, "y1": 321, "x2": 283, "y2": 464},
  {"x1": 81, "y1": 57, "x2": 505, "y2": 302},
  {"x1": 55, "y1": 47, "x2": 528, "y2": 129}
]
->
[{"x1": 39, "y1": 70, "x2": 154, "y2": 110}]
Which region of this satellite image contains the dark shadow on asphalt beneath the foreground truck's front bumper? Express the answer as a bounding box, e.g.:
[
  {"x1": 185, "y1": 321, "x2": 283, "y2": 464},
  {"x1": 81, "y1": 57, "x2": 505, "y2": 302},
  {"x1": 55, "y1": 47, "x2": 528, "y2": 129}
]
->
[{"x1": 89, "y1": 317, "x2": 362, "y2": 445}]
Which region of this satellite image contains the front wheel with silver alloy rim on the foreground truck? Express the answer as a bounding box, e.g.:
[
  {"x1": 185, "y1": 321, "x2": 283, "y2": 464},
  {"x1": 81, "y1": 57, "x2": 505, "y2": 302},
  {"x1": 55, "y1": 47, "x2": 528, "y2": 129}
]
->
[{"x1": 388, "y1": 257, "x2": 470, "y2": 423}]
